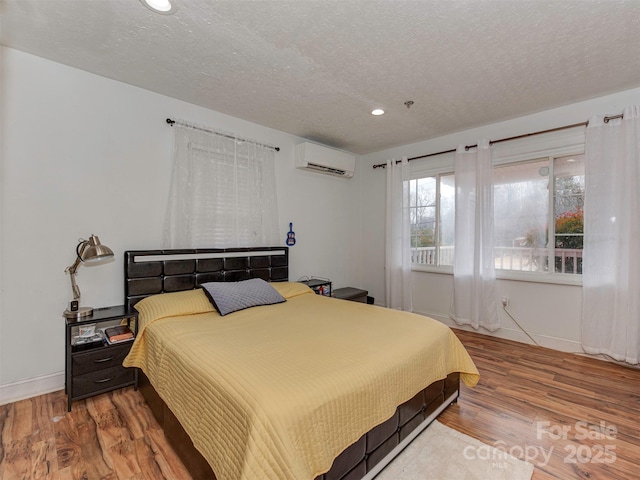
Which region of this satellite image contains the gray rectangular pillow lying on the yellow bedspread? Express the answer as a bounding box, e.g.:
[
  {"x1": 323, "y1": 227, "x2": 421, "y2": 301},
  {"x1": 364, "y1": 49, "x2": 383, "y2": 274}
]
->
[{"x1": 202, "y1": 278, "x2": 286, "y2": 316}]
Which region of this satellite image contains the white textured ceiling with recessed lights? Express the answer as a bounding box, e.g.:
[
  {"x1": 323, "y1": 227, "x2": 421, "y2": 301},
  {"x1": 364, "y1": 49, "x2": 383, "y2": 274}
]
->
[{"x1": 0, "y1": 0, "x2": 640, "y2": 154}]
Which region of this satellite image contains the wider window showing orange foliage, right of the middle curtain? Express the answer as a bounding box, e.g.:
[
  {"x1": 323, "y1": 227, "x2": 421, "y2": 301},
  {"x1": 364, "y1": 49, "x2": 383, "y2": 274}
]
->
[{"x1": 493, "y1": 155, "x2": 584, "y2": 274}]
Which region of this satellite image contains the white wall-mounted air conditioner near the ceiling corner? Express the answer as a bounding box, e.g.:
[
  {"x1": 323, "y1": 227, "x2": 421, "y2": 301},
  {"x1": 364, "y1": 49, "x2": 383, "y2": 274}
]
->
[{"x1": 296, "y1": 142, "x2": 356, "y2": 178}]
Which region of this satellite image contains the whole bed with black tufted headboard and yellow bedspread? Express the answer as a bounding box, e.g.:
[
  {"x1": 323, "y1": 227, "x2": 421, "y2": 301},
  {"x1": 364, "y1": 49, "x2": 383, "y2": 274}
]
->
[{"x1": 125, "y1": 247, "x2": 479, "y2": 480}]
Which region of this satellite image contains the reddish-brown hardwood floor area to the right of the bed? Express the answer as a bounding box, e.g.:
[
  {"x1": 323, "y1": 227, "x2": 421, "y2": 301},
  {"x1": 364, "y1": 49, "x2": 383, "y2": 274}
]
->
[{"x1": 439, "y1": 330, "x2": 640, "y2": 480}]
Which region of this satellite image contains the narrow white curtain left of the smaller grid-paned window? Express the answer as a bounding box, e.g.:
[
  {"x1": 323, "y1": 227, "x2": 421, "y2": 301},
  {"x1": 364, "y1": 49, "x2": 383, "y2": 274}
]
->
[{"x1": 385, "y1": 157, "x2": 413, "y2": 312}]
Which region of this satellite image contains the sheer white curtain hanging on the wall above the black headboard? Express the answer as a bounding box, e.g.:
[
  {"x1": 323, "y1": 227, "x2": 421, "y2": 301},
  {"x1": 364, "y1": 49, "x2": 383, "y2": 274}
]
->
[{"x1": 163, "y1": 122, "x2": 284, "y2": 248}]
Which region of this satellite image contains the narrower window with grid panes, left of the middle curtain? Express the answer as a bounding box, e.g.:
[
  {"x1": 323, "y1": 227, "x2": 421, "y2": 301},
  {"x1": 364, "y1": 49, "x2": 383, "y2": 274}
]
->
[{"x1": 409, "y1": 173, "x2": 455, "y2": 265}]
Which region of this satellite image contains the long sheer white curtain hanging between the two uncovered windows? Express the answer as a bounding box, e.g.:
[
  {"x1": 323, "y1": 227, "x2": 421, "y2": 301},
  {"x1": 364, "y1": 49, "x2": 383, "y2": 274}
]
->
[{"x1": 451, "y1": 140, "x2": 500, "y2": 331}]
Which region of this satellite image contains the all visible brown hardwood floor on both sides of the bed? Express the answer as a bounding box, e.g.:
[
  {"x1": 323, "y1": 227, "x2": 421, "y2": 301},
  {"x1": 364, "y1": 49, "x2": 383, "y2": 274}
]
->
[{"x1": 0, "y1": 331, "x2": 640, "y2": 480}]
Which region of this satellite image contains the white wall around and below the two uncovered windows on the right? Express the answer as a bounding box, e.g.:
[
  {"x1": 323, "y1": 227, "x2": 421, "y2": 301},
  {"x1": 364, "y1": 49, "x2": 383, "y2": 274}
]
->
[{"x1": 361, "y1": 88, "x2": 640, "y2": 351}]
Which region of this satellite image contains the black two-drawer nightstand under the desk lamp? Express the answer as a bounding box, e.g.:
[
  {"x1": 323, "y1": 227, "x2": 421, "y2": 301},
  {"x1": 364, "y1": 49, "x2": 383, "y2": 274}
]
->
[{"x1": 64, "y1": 305, "x2": 138, "y2": 412}]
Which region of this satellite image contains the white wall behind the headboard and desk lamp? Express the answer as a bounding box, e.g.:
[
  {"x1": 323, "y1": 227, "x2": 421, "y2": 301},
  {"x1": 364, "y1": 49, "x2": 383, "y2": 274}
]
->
[{"x1": 0, "y1": 48, "x2": 361, "y2": 403}]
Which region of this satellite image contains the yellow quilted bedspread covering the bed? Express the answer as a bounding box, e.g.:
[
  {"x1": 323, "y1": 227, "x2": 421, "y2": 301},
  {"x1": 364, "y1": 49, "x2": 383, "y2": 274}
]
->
[{"x1": 125, "y1": 283, "x2": 479, "y2": 480}]
